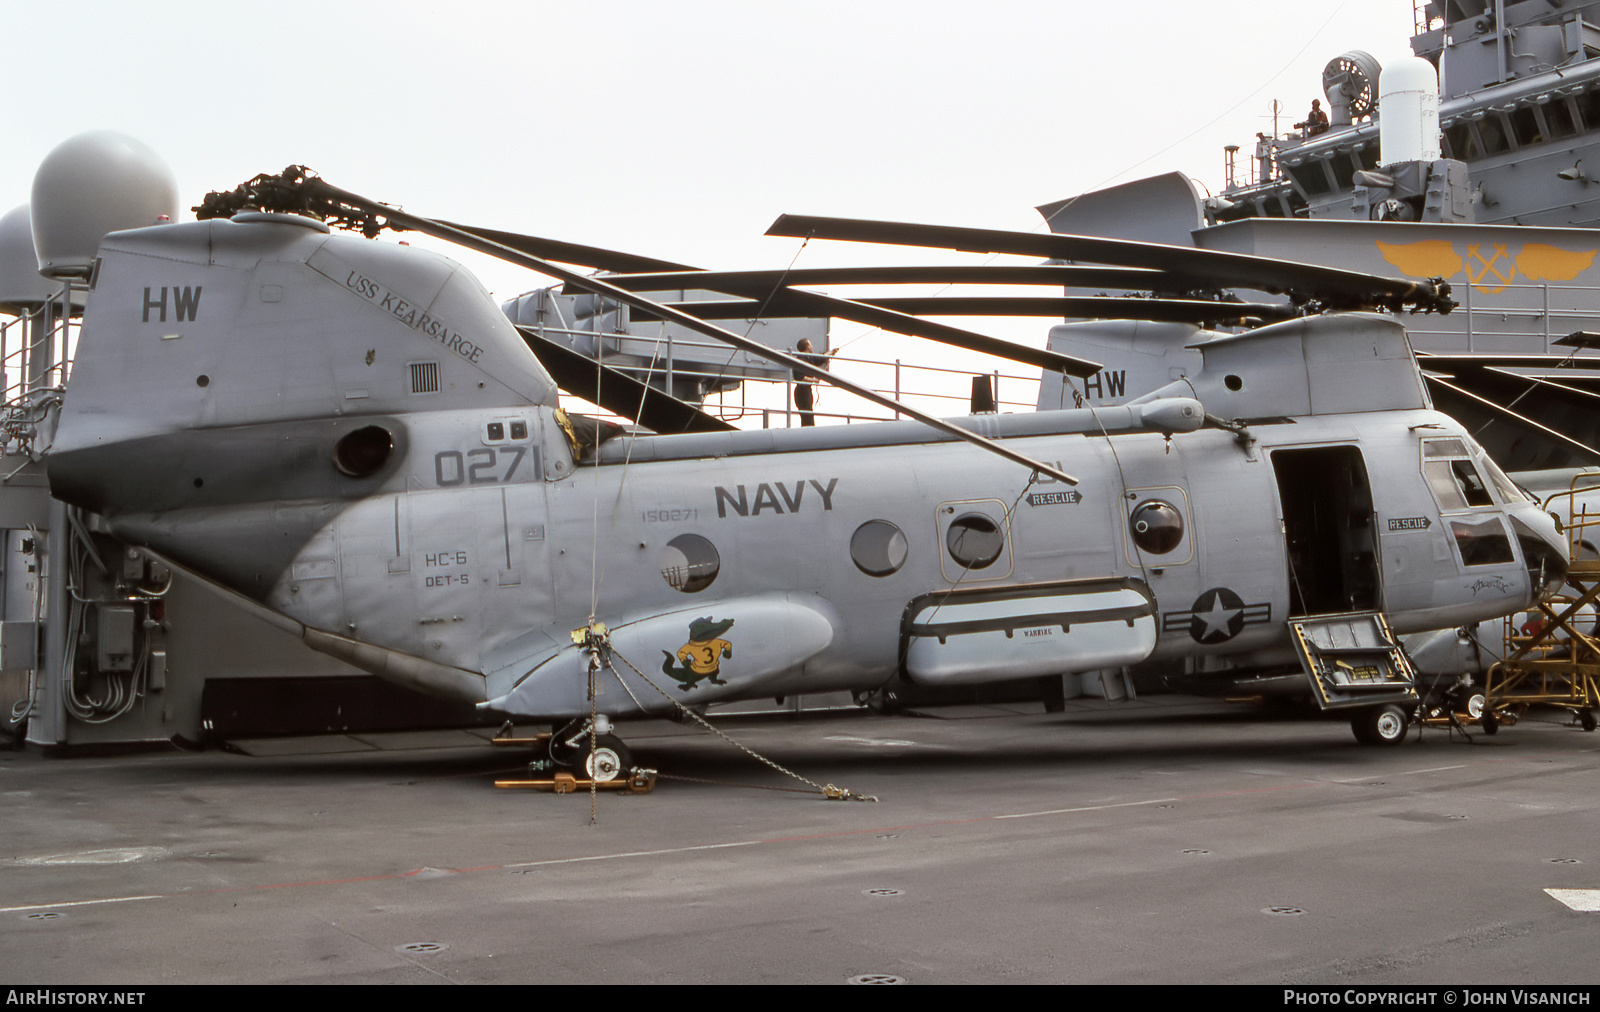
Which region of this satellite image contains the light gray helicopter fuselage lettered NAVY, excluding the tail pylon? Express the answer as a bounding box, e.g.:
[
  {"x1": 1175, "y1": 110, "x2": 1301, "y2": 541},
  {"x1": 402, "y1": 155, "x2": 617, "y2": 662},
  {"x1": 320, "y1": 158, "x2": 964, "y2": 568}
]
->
[{"x1": 252, "y1": 398, "x2": 1547, "y2": 716}]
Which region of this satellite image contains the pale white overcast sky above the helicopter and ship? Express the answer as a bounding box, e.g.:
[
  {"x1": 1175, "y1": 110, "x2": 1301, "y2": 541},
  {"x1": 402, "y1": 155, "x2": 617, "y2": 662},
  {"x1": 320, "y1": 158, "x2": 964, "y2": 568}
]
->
[{"x1": 0, "y1": 0, "x2": 1413, "y2": 419}]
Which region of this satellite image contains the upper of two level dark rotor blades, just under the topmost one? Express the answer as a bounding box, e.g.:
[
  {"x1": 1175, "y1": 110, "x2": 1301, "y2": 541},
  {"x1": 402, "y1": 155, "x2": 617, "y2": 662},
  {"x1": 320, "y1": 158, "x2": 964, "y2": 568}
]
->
[{"x1": 592, "y1": 258, "x2": 1194, "y2": 289}]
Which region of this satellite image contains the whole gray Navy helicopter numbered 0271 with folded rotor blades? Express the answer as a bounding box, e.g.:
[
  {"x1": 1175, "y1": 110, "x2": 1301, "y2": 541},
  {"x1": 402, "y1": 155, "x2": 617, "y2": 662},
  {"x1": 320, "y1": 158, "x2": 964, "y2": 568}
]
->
[{"x1": 46, "y1": 161, "x2": 1565, "y2": 778}]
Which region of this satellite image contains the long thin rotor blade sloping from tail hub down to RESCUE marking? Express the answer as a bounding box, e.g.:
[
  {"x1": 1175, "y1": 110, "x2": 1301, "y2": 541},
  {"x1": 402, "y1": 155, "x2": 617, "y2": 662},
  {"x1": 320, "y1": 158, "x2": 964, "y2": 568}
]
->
[{"x1": 301, "y1": 176, "x2": 1078, "y2": 485}]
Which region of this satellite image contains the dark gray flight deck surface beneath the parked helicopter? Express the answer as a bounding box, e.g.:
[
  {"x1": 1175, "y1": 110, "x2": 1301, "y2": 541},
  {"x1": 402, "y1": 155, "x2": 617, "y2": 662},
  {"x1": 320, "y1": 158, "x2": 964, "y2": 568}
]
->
[{"x1": 0, "y1": 697, "x2": 1600, "y2": 986}]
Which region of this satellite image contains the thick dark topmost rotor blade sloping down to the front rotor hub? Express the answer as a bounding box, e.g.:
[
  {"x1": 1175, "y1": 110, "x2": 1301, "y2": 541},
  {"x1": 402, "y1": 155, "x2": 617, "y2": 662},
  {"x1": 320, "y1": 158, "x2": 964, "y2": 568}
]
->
[{"x1": 766, "y1": 215, "x2": 1454, "y2": 312}]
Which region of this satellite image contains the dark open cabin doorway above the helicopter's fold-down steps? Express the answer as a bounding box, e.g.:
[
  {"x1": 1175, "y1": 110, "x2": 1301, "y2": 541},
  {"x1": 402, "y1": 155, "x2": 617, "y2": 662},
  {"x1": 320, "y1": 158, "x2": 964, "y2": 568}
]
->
[{"x1": 1272, "y1": 445, "x2": 1381, "y2": 616}]
